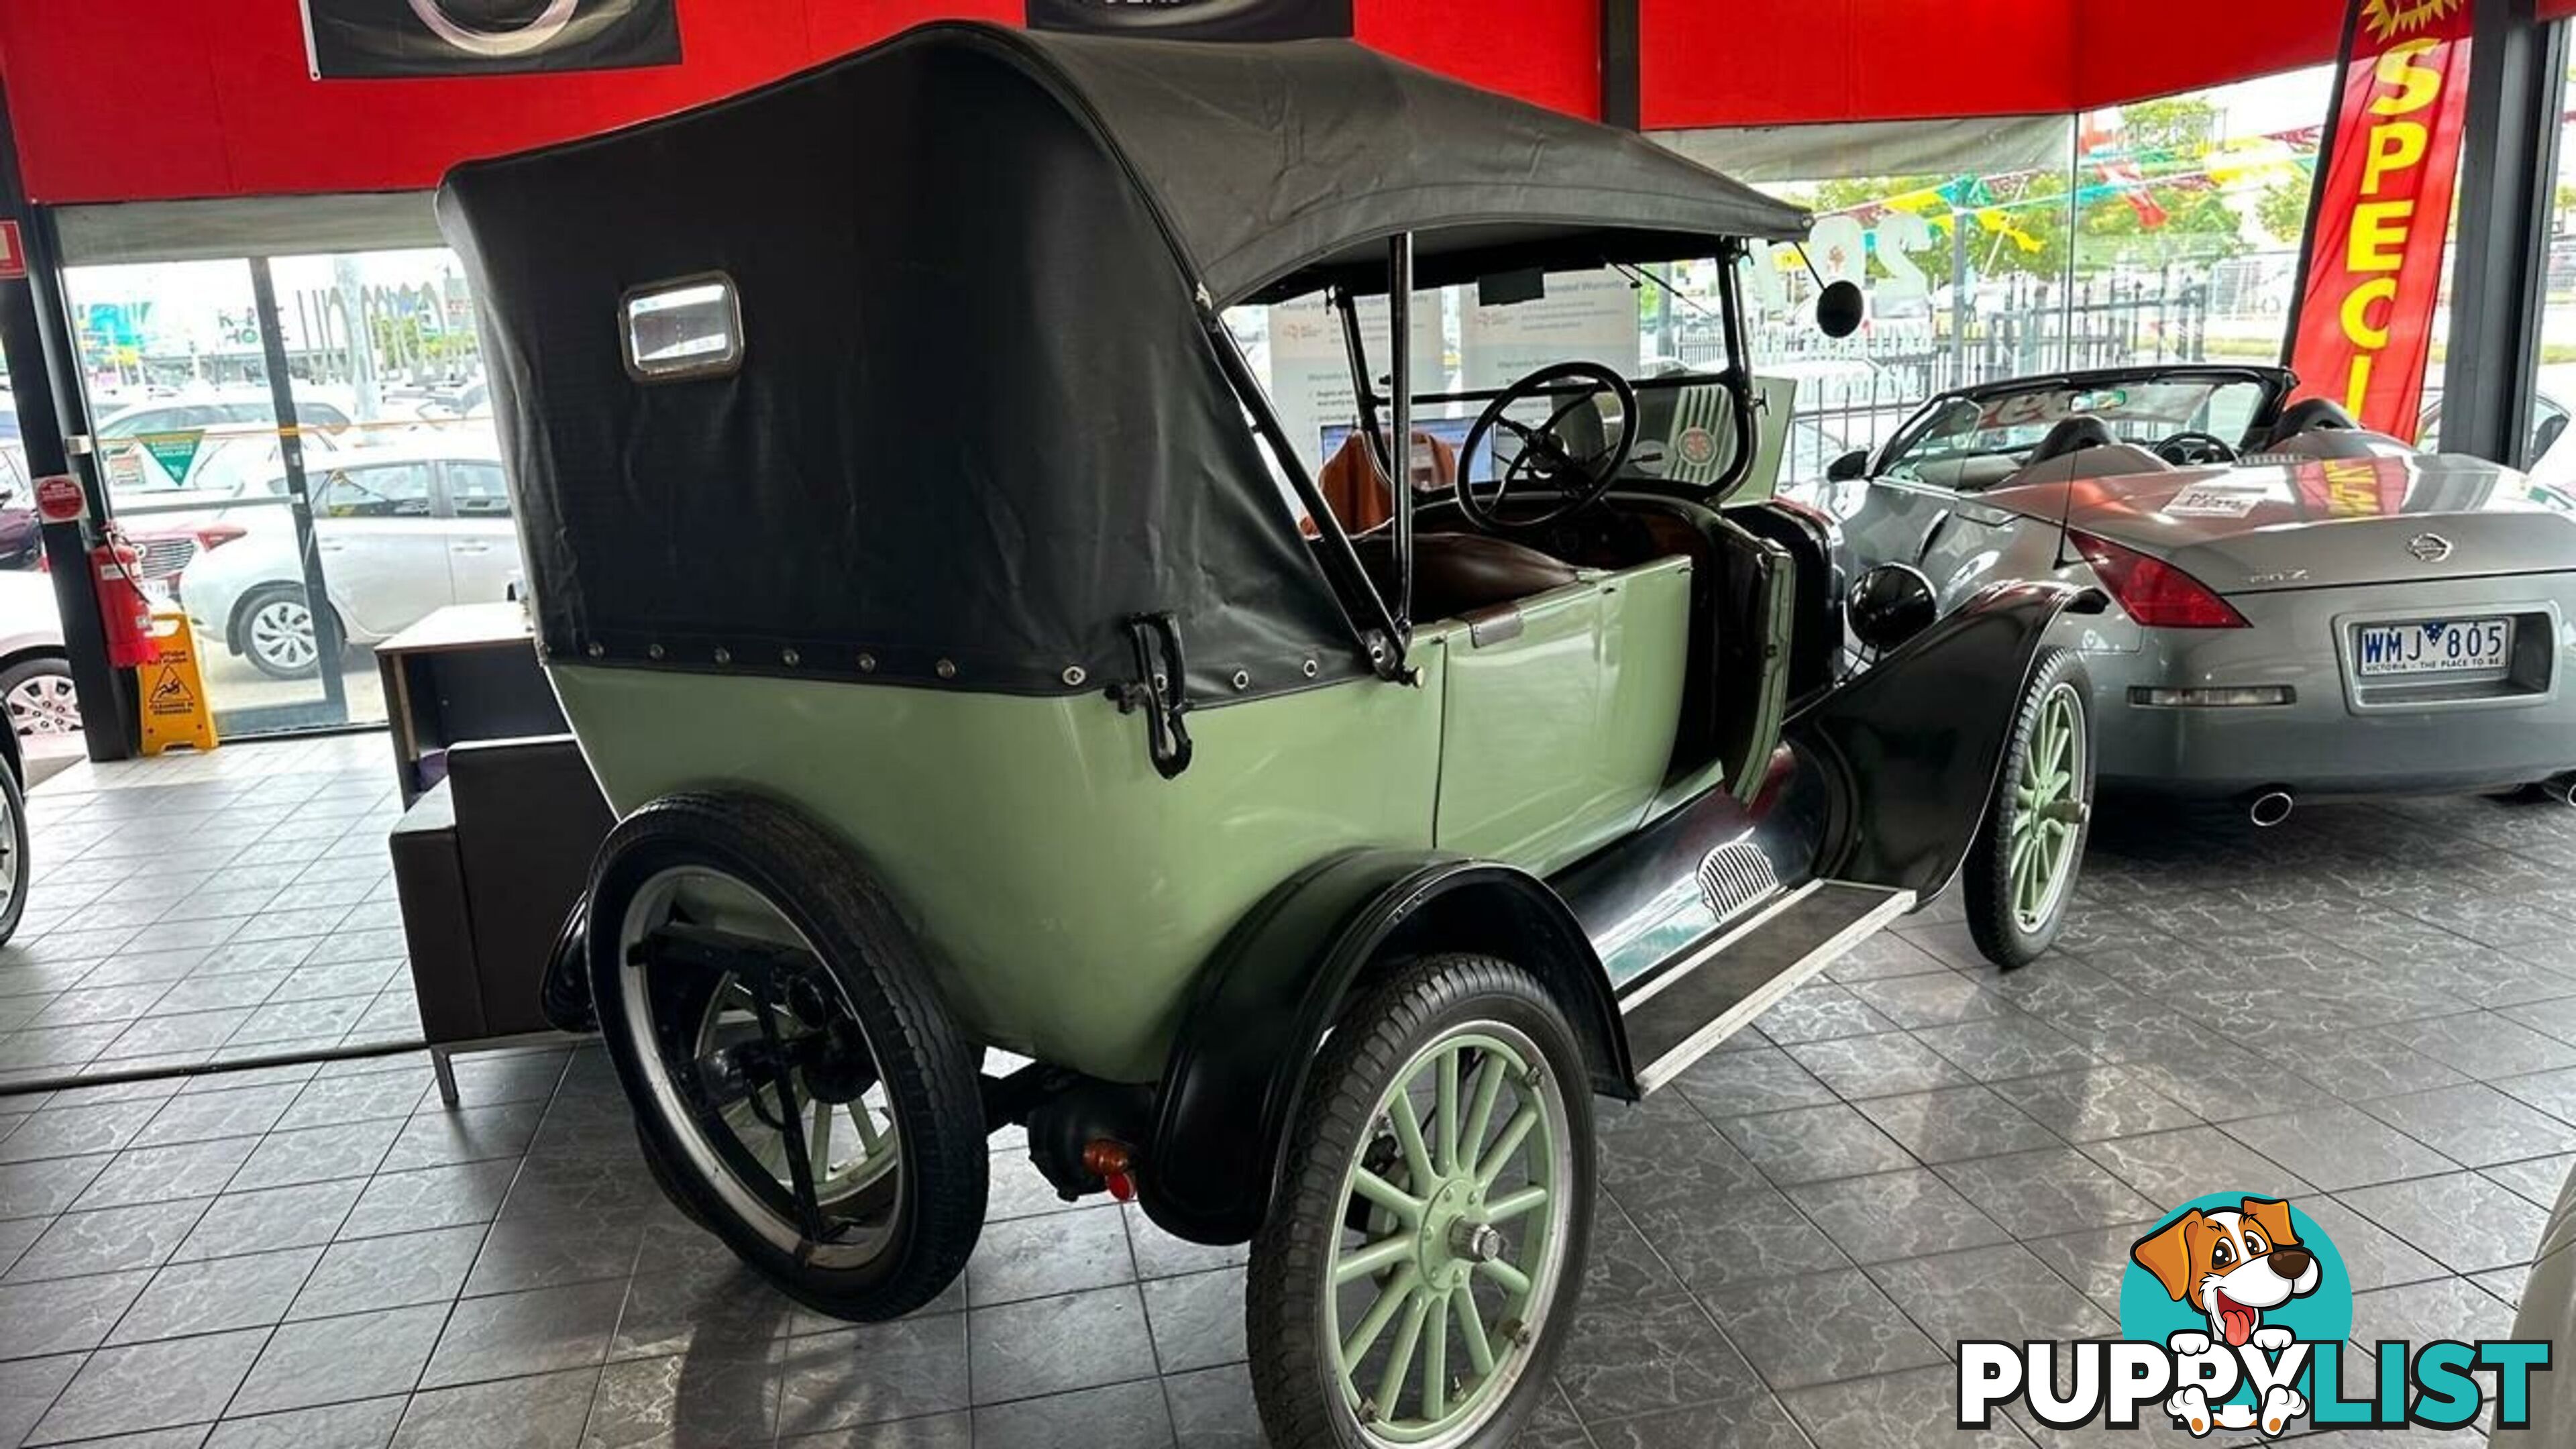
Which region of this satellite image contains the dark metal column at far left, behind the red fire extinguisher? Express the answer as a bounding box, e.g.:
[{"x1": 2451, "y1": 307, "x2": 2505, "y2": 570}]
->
[{"x1": 0, "y1": 76, "x2": 134, "y2": 761}]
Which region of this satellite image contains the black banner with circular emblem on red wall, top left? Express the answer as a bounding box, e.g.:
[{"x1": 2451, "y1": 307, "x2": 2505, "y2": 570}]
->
[{"x1": 304, "y1": 0, "x2": 680, "y2": 80}]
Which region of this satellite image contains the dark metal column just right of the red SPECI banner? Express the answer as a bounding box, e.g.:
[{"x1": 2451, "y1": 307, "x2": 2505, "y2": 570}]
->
[{"x1": 2439, "y1": 0, "x2": 2568, "y2": 467}]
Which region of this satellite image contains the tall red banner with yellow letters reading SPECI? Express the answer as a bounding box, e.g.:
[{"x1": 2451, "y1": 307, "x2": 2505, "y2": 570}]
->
[{"x1": 2290, "y1": 0, "x2": 2471, "y2": 441}]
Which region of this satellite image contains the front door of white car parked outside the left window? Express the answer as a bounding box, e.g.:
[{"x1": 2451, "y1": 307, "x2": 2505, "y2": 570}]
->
[{"x1": 314, "y1": 462, "x2": 453, "y2": 639}]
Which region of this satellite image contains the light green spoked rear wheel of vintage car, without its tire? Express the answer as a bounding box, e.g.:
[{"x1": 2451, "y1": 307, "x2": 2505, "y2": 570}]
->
[{"x1": 1322, "y1": 1021, "x2": 1571, "y2": 1446}]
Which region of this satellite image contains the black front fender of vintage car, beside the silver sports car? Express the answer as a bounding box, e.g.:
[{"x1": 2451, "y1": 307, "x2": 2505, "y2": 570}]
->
[{"x1": 1788, "y1": 583, "x2": 2100, "y2": 900}]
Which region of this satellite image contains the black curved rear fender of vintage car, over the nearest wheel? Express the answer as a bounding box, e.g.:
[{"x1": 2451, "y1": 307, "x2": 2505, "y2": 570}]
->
[{"x1": 1136, "y1": 851, "x2": 1633, "y2": 1243}]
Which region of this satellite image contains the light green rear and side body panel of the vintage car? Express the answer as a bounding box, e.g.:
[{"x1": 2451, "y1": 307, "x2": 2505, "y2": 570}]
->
[{"x1": 549, "y1": 559, "x2": 1690, "y2": 1083}]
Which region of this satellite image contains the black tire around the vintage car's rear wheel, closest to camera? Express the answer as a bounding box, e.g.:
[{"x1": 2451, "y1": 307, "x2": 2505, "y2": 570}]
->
[{"x1": 1244, "y1": 957, "x2": 1595, "y2": 1449}]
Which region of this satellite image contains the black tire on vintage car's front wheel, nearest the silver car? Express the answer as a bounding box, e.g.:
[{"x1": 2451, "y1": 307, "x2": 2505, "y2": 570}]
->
[{"x1": 1957, "y1": 647, "x2": 2094, "y2": 972}]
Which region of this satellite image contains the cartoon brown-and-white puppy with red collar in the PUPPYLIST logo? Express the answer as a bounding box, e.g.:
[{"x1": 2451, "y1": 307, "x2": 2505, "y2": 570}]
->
[{"x1": 2128, "y1": 1196, "x2": 2324, "y2": 1434}]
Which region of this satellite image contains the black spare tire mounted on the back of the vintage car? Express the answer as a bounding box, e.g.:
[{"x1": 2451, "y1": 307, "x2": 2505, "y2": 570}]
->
[{"x1": 590, "y1": 794, "x2": 987, "y2": 1323}]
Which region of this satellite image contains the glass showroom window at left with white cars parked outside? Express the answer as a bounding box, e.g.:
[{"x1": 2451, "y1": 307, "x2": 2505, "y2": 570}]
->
[{"x1": 62, "y1": 196, "x2": 497, "y2": 737}]
